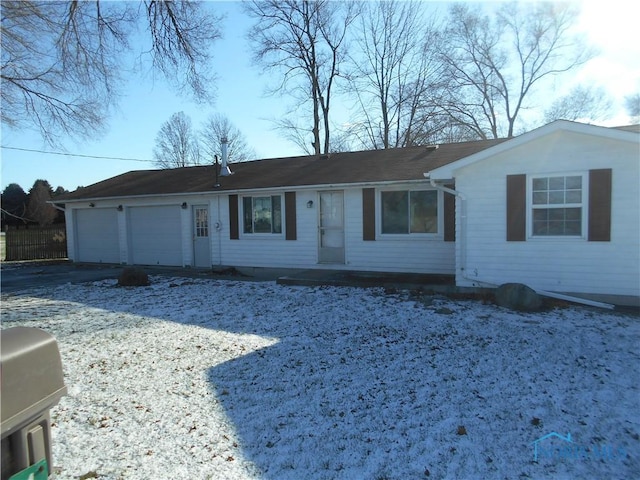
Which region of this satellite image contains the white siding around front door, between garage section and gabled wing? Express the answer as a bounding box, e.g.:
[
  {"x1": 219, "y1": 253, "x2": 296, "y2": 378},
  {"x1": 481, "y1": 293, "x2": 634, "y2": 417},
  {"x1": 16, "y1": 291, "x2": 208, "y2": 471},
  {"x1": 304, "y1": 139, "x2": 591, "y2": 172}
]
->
[{"x1": 212, "y1": 187, "x2": 455, "y2": 275}]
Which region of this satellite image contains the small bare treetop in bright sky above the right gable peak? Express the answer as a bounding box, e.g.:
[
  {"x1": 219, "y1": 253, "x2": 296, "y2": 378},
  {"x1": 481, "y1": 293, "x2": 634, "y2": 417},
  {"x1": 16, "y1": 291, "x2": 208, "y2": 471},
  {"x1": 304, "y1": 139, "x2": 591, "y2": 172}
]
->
[{"x1": 544, "y1": 85, "x2": 611, "y2": 123}]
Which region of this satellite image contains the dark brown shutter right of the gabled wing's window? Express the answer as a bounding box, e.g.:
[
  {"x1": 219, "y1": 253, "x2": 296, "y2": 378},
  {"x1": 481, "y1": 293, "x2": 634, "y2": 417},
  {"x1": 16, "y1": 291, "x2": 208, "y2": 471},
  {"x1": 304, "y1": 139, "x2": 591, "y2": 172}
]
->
[{"x1": 588, "y1": 168, "x2": 611, "y2": 242}]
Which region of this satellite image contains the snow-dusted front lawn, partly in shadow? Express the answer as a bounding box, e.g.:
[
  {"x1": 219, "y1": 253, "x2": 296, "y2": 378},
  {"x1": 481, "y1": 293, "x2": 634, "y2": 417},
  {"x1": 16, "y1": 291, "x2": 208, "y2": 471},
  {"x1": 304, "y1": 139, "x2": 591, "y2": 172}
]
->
[{"x1": 2, "y1": 277, "x2": 640, "y2": 480}]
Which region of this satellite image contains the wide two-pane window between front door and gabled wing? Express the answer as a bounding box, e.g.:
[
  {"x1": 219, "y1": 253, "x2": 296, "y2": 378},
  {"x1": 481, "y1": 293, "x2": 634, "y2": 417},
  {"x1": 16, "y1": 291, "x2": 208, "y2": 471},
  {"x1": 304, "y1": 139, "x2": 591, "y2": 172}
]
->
[{"x1": 380, "y1": 190, "x2": 438, "y2": 234}]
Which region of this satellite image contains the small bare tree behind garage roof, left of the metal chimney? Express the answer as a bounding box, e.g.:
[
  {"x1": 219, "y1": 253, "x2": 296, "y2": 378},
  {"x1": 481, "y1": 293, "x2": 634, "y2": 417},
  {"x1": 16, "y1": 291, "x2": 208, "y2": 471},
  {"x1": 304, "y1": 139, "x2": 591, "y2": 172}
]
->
[{"x1": 153, "y1": 112, "x2": 200, "y2": 168}]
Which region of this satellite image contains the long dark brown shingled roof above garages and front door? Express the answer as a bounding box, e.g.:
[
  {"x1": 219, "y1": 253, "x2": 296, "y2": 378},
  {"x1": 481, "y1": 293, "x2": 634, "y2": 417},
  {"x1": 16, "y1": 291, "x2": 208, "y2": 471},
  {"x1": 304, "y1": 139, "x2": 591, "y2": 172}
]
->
[{"x1": 56, "y1": 139, "x2": 505, "y2": 202}]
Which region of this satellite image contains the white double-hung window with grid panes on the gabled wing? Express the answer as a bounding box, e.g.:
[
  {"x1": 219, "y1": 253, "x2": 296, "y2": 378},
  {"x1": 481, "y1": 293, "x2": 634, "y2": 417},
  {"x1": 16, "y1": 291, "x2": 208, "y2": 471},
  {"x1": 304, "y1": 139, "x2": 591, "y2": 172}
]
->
[{"x1": 531, "y1": 175, "x2": 585, "y2": 237}]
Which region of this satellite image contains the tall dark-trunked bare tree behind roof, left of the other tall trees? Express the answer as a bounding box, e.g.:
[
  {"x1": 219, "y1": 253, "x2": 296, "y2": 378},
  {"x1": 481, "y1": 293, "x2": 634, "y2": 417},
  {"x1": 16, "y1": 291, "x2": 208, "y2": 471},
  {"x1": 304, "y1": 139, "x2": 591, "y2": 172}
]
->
[{"x1": 247, "y1": 0, "x2": 356, "y2": 155}]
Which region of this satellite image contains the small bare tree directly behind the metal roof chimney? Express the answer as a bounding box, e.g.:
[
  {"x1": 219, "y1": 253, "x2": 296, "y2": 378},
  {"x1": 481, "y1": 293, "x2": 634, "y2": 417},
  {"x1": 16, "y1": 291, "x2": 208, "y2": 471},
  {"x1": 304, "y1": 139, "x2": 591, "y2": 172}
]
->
[{"x1": 200, "y1": 114, "x2": 255, "y2": 163}]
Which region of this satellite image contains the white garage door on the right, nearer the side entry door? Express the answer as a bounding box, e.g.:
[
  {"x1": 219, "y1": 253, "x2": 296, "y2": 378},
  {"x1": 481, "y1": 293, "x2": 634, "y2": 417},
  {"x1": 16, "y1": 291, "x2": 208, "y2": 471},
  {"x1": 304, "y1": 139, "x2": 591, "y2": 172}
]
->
[{"x1": 129, "y1": 206, "x2": 182, "y2": 266}]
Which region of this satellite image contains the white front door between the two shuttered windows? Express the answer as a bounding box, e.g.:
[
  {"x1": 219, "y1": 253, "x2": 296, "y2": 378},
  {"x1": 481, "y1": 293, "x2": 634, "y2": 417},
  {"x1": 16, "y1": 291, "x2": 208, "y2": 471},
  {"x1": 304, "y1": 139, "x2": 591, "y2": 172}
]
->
[{"x1": 318, "y1": 191, "x2": 344, "y2": 263}]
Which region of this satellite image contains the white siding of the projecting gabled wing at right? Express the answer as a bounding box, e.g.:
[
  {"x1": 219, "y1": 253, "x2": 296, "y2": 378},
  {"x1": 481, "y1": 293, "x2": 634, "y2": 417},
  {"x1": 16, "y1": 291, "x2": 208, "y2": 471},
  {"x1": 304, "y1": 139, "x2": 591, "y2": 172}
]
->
[{"x1": 456, "y1": 132, "x2": 640, "y2": 296}]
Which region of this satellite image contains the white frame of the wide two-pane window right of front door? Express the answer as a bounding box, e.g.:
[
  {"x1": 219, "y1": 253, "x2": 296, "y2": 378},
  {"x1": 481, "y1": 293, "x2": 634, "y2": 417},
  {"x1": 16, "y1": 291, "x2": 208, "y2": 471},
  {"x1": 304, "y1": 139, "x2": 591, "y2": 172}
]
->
[{"x1": 376, "y1": 185, "x2": 444, "y2": 240}]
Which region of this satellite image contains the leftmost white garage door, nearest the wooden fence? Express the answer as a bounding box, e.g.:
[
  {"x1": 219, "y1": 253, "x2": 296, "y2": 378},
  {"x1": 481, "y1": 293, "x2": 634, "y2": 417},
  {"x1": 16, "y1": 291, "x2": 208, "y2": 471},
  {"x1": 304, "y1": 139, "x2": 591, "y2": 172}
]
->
[{"x1": 75, "y1": 208, "x2": 120, "y2": 263}]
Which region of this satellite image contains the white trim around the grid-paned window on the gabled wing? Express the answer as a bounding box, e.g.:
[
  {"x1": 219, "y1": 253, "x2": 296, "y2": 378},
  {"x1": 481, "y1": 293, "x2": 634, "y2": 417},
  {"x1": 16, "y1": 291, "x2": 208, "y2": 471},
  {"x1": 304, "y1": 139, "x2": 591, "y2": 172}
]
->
[{"x1": 526, "y1": 171, "x2": 589, "y2": 242}]
